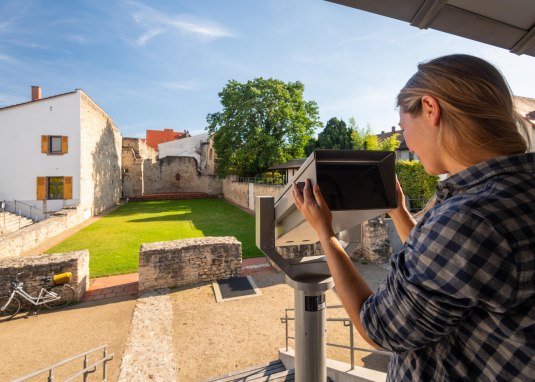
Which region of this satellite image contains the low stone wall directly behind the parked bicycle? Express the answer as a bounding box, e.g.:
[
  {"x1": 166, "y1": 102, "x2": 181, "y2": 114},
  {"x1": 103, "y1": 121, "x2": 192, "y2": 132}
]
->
[{"x1": 0, "y1": 250, "x2": 89, "y2": 302}]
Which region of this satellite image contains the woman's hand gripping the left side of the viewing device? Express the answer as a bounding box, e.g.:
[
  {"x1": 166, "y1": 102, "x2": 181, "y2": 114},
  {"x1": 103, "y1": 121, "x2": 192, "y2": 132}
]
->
[{"x1": 292, "y1": 179, "x2": 334, "y2": 238}]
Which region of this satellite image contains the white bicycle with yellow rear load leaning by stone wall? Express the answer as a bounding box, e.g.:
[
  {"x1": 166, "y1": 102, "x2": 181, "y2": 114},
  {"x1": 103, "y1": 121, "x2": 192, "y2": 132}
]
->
[{"x1": 0, "y1": 272, "x2": 74, "y2": 322}]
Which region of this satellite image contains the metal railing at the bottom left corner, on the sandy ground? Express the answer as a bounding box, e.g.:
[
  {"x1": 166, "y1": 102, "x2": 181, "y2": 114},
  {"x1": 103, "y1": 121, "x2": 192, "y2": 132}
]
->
[{"x1": 11, "y1": 345, "x2": 114, "y2": 382}]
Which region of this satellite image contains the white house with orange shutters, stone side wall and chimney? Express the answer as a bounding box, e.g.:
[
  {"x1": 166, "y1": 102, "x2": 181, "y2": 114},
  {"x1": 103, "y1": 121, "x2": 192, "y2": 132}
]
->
[{"x1": 0, "y1": 86, "x2": 122, "y2": 220}]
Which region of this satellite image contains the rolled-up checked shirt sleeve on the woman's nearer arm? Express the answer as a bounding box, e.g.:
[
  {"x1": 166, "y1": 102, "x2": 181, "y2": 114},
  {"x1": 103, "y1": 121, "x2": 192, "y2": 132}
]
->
[{"x1": 360, "y1": 207, "x2": 517, "y2": 352}]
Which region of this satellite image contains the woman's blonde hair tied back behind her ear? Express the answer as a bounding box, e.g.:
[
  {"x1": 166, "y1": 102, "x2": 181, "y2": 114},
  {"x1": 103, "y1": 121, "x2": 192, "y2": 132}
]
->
[{"x1": 397, "y1": 54, "x2": 528, "y2": 165}]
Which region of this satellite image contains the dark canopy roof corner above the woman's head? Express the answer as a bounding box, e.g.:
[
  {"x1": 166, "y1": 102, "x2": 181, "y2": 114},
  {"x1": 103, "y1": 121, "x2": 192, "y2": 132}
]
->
[{"x1": 327, "y1": 0, "x2": 535, "y2": 57}]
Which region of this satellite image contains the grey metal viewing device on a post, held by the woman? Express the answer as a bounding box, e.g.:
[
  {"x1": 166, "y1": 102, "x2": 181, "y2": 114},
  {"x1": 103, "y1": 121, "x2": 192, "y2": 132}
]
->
[{"x1": 255, "y1": 150, "x2": 397, "y2": 382}]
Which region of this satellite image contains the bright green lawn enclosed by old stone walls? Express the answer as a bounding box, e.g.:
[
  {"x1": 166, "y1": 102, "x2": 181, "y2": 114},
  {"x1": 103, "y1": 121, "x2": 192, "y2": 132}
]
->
[{"x1": 47, "y1": 199, "x2": 263, "y2": 278}]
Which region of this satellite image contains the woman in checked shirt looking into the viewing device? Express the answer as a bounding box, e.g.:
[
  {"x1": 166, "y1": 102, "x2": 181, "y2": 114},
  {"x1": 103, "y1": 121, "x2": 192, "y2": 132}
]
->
[{"x1": 293, "y1": 55, "x2": 535, "y2": 381}]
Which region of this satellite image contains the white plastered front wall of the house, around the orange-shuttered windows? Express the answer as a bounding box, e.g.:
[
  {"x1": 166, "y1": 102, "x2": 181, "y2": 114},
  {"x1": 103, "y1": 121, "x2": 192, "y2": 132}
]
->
[{"x1": 0, "y1": 92, "x2": 80, "y2": 216}]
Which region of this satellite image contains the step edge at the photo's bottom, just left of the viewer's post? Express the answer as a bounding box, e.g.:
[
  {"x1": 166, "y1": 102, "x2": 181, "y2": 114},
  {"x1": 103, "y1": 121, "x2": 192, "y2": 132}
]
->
[{"x1": 204, "y1": 360, "x2": 294, "y2": 382}]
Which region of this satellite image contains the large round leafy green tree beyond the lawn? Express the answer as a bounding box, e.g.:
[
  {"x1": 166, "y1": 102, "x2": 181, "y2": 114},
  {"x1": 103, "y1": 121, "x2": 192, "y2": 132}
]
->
[{"x1": 206, "y1": 78, "x2": 320, "y2": 176}]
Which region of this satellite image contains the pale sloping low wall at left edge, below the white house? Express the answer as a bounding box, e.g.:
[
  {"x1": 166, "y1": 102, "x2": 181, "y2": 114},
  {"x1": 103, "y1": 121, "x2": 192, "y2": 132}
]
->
[{"x1": 0, "y1": 206, "x2": 85, "y2": 259}]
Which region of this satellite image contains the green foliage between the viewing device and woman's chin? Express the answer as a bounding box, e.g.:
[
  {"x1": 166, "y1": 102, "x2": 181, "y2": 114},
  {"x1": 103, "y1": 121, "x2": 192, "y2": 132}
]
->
[{"x1": 396, "y1": 160, "x2": 439, "y2": 210}]
